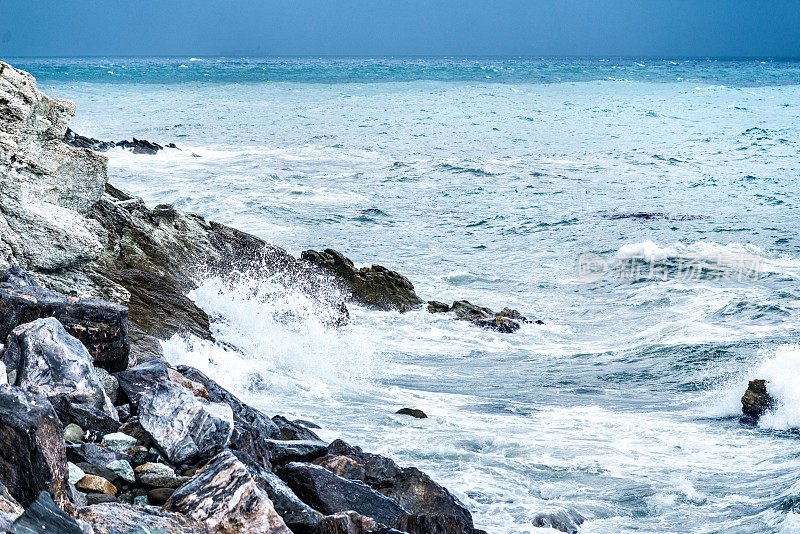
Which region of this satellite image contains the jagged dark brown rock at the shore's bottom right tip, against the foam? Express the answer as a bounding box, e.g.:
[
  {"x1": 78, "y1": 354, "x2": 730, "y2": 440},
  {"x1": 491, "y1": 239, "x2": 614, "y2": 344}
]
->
[{"x1": 314, "y1": 440, "x2": 473, "y2": 534}]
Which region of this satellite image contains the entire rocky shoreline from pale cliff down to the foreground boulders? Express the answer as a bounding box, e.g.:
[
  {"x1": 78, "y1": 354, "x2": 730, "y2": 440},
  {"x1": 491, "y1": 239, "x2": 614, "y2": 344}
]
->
[{"x1": 0, "y1": 60, "x2": 526, "y2": 534}]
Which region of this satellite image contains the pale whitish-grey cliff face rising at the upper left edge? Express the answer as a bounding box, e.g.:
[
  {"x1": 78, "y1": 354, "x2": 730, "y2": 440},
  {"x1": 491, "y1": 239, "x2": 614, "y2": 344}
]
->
[{"x1": 0, "y1": 66, "x2": 107, "y2": 292}]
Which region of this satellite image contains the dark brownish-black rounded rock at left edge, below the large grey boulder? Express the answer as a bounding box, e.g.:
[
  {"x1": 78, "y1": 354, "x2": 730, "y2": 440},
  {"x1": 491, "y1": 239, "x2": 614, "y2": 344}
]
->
[{"x1": 0, "y1": 385, "x2": 68, "y2": 506}]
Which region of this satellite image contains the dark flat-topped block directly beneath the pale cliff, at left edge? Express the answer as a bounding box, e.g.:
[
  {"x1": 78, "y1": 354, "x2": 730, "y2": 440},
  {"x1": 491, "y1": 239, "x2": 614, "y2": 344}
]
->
[{"x1": 0, "y1": 275, "x2": 130, "y2": 371}]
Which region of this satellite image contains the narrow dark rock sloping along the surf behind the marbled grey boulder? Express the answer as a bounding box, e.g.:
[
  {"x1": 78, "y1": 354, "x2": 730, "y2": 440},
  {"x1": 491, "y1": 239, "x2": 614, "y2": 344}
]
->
[{"x1": 178, "y1": 365, "x2": 281, "y2": 467}]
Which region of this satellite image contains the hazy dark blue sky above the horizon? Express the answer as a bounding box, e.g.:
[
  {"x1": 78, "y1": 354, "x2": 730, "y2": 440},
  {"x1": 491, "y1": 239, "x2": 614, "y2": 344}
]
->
[{"x1": 0, "y1": 0, "x2": 800, "y2": 57}]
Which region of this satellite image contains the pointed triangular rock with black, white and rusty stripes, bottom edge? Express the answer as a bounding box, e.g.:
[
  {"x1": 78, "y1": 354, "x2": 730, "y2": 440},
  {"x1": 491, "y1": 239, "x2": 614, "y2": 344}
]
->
[{"x1": 164, "y1": 451, "x2": 291, "y2": 534}]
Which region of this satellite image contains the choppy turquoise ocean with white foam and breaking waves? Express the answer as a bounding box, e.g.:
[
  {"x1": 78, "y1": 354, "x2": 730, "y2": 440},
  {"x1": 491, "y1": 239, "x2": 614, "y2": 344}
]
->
[{"x1": 8, "y1": 57, "x2": 800, "y2": 534}]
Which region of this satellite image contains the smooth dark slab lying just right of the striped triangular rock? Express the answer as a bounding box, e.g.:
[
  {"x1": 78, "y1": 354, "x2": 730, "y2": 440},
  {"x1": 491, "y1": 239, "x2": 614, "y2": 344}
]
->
[{"x1": 278, "y1": 462, "x2": 407, "y2": 525}]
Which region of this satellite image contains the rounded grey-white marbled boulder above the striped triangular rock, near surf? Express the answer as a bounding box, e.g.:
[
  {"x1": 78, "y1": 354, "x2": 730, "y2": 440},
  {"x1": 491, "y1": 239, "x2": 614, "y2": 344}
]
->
[{"x1": 139, "y1": 382, "x2": 233, "y2": 465}]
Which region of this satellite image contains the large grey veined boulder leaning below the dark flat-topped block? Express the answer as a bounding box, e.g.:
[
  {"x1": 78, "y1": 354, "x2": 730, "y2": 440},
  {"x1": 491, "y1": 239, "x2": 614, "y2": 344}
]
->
[{"x1": 3, "y1": 317, "x2": 119, "y2": 432}]
